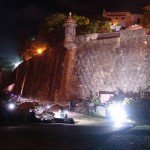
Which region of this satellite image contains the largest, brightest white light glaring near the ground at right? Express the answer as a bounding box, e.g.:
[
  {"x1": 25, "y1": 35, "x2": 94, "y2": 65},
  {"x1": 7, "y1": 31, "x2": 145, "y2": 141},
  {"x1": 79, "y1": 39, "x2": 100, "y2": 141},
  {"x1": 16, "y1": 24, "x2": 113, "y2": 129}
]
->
[{"x1": 109, "y1": 103, "x2": 127, "y2": 127}]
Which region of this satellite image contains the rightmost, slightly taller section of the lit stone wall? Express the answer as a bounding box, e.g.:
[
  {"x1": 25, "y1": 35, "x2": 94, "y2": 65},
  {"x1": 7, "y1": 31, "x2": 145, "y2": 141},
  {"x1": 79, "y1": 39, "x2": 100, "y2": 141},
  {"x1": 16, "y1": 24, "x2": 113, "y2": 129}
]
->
[{"x1": 117, "y1": 30, "x2": 150, "y2": 92}]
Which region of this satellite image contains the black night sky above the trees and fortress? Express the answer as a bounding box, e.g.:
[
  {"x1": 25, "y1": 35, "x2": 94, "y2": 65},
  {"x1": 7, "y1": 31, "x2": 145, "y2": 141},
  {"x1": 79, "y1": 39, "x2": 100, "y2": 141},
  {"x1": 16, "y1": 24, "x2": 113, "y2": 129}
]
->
[{"x1": 0, "y1": 0, "x2": 150, "y2": 60}]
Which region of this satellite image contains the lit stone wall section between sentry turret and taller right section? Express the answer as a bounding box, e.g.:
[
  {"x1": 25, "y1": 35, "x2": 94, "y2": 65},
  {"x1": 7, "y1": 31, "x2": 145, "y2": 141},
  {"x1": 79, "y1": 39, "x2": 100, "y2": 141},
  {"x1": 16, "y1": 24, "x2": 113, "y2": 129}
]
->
[{"x1": 69, "y1": 35, "x2": 120, "y2": 98}]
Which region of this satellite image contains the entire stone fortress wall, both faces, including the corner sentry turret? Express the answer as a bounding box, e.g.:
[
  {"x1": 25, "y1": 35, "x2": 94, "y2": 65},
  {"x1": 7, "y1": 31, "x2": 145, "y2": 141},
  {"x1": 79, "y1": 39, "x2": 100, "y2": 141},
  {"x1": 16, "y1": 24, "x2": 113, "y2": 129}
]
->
[{"x1": 11, "y1": 15, "x2": 150, "y2": 102}]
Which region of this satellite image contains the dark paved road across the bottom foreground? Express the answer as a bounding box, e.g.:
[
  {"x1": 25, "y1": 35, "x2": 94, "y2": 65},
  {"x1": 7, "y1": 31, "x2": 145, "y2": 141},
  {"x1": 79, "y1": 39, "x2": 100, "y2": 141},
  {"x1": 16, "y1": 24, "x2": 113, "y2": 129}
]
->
[{"x1": 0, "y1": 124, "x2": 132, "y2": 150}]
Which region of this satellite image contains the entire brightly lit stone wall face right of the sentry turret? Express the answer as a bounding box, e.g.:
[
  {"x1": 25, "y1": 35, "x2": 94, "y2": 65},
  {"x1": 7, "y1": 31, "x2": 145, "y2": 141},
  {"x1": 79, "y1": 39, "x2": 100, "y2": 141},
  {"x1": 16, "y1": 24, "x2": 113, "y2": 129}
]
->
[{"x1": 68, "y1": 29, "x2": 150, "y2": 99}]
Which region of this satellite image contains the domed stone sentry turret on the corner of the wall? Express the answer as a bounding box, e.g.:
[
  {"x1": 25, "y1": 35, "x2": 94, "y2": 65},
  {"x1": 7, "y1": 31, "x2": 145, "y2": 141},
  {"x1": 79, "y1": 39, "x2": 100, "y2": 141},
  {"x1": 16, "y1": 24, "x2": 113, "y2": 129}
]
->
[{"x1": 64, "y1": 13, "x2": 77, "y2": 50}]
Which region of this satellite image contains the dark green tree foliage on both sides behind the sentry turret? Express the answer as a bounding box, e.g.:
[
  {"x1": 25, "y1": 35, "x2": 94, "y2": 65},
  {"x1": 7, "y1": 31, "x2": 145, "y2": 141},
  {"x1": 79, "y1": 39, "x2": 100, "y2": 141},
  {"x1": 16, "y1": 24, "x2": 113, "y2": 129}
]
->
[{"x1": 38, "y1": 13, "x2": 110, "y2": 40}]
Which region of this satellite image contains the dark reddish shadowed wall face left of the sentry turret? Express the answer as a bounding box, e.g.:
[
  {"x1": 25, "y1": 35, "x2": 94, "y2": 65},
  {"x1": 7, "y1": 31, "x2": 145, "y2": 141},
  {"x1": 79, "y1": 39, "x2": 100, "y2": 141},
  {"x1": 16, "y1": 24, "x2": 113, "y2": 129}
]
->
[{"x1": 15, "y1": 46, "x2": 69, "y2": 101}]
